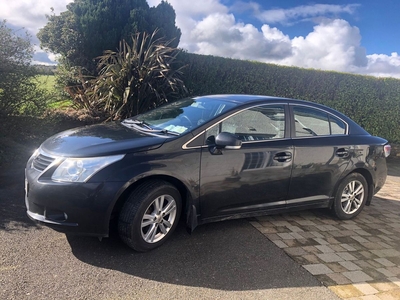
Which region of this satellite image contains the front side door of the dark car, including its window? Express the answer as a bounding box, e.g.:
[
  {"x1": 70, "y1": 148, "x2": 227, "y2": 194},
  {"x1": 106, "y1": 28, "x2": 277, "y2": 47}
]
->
[{"x1": 200, "y1": 104, "x2": 293, "y2": 219}]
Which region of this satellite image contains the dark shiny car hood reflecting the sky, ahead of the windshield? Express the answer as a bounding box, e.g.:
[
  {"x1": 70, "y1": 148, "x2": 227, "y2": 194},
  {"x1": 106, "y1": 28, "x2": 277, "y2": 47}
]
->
[{"x1": 41, "y1": 122, "x2": 166, "y2": 157}]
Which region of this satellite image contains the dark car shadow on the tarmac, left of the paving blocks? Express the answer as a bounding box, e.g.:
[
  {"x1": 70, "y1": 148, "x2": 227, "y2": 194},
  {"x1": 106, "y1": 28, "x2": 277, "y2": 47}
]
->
[{"x1": 67, "y1": 220, "x2": 321, "y2": 291}]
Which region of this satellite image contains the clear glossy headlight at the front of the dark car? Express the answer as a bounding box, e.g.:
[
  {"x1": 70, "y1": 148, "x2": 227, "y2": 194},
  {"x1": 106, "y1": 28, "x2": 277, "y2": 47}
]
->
[{"x1": 51, "y1": 155, "x2": 124, "y2": 182}]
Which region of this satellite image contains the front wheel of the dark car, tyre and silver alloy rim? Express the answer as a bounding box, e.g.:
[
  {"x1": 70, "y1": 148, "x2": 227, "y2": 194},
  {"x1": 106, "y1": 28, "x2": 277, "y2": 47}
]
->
[{"x1": 118, "y1": 180, "x2": 182, "y2": 252}]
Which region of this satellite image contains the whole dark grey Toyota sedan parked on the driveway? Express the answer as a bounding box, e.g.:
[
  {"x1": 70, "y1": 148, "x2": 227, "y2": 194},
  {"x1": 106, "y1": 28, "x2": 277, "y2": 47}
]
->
[{"x1": 25, "y1": 95, "x2": 390, "y2": 251}]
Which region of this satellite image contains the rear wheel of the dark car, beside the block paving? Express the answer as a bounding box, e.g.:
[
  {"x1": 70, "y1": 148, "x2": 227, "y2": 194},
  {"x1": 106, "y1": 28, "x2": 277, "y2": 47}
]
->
[{"x1": 333, "y1": 173, "x2": 368, "y2": 220}]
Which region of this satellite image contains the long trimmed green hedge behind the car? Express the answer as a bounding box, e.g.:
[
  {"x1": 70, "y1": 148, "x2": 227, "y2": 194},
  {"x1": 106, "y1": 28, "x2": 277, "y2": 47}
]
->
[{"x1": 179, "y1": 52, "x2": 400, "y2": 143}]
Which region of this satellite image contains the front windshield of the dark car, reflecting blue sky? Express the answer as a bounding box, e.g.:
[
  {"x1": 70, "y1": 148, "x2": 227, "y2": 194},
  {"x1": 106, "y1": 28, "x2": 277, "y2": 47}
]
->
[{"x1": 122, "y1": 98, "x2": 237, "y2": 135}]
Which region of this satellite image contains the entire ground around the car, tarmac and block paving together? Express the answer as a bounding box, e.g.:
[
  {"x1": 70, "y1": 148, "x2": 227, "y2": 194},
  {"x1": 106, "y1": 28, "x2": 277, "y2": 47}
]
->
[{"x1": 0, "y1": 160, "x2": 400, "y2": 299}]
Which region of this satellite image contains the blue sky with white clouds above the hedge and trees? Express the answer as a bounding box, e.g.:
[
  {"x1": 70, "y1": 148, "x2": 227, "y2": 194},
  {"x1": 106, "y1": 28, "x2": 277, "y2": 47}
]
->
[{"x1": 0, "y1": 0, "x2": 400, "y2": 78}]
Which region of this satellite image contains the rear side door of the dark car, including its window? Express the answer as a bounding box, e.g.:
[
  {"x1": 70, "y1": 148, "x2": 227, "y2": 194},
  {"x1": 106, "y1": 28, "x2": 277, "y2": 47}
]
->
[{"x1": 287, "y1": 105, "x2": 353, "y2": 206}]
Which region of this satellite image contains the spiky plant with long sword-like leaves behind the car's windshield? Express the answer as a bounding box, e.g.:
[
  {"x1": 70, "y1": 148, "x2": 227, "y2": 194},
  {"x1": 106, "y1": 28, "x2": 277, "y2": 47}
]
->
[{"x1": 67, "y1": 31, "x2": 186, "y2": 120}]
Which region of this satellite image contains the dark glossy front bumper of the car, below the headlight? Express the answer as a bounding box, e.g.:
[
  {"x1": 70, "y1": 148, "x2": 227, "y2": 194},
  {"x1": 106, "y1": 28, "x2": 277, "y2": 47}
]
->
[{"x1": 25, "y1": 164, "x2": 124, "y2": 237}]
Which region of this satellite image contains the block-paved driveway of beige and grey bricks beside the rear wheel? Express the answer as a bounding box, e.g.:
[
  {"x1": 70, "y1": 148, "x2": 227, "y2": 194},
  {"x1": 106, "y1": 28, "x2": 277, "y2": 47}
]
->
[{"x1": 251, "y1": 159, "x2": 400, "y2": 300}]
